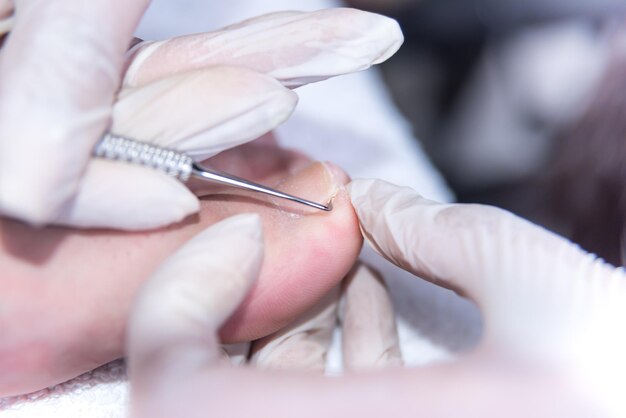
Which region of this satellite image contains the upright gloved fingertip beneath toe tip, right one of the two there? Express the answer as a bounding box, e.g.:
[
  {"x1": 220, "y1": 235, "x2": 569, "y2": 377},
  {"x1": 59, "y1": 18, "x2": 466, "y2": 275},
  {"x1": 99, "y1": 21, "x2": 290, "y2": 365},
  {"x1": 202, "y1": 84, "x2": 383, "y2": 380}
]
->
[{"x1": 340, "y1": 263, "x2": 402, "y2": 370}]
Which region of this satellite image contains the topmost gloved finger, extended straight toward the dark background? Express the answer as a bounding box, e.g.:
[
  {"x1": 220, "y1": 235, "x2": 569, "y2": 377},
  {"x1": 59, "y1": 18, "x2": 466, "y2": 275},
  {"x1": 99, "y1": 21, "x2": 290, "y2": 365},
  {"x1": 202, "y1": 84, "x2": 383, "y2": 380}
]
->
[{"x1": 124, "y1": 8, "x2": 403, "y2": 87}]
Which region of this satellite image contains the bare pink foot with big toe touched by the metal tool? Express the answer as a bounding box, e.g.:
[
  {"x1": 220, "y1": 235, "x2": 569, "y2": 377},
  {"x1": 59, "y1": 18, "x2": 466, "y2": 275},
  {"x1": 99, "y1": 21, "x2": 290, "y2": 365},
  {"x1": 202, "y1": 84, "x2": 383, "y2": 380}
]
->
[{"x1": 0, "y1": 138, "x2": 362, "y2": 396}]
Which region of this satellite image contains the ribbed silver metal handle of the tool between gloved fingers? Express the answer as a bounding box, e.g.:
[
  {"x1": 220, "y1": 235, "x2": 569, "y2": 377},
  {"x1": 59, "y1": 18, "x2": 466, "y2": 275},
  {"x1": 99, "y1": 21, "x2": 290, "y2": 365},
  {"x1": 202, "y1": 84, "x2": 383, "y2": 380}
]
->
[{"x1": 94, "y1": 133, "x2": 193, "y2": 182}]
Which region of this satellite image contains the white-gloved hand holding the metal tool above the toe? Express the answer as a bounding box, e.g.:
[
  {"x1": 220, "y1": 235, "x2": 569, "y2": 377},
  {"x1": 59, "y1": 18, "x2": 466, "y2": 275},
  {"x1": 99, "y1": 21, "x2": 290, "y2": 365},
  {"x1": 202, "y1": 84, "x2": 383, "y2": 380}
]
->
[{"x1": 0, "y1": 6, "x2": 402, "y2": 229}]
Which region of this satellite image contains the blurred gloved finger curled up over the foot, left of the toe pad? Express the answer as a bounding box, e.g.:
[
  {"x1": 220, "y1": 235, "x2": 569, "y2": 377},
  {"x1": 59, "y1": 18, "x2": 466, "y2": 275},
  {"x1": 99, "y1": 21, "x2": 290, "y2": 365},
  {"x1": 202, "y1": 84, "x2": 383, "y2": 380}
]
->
[{"x1": 127, "y1": 214, "x2": 263, "y2": 397}]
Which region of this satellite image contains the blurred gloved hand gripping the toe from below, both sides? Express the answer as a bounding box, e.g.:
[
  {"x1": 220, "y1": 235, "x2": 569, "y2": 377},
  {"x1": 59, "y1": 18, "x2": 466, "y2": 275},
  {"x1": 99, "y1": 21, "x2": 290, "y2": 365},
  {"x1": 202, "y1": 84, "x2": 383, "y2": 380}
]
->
[{"x1": 128, "y1": 180, "x2": 626, "y2": 417}]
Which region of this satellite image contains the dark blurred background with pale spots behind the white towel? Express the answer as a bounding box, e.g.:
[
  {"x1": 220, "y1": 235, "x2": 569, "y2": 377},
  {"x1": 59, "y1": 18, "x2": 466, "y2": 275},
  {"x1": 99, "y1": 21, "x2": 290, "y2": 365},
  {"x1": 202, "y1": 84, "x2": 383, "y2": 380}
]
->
[{"x1": 348, "y1": 0, "x2": 626, "y2": 265}]
